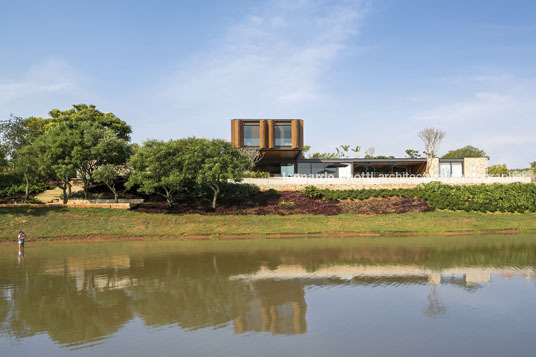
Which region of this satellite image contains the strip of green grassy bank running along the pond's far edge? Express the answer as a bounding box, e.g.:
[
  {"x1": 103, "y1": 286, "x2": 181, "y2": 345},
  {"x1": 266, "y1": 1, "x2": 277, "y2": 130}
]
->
[{"x1": 0, "y1": 207, "x2": 536, "y2": 240}]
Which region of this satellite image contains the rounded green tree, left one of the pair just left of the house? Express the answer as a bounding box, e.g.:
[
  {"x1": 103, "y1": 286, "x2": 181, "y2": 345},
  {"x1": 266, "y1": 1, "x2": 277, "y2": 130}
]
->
[{"x1": 126, "y1": 139, "x2": 194, "y2": 207}]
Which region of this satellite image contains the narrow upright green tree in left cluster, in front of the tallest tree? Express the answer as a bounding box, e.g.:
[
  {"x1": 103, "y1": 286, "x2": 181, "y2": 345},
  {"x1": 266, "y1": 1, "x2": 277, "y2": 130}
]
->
[{"x1": 34, "y1": 124, "x2": 80, "y2": 204}]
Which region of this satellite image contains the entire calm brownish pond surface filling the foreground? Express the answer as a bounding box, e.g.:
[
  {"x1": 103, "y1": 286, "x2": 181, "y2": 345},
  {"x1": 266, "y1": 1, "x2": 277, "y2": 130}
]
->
[{"x1": 0, "y1": 235, "x2": 536, "y2": 357}]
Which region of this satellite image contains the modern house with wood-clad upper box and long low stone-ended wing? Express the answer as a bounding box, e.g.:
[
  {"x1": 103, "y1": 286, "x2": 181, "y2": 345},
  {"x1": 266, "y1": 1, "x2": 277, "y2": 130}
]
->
[{"x1": 231, "y1": 119, "x2": 488, "y2": 178}]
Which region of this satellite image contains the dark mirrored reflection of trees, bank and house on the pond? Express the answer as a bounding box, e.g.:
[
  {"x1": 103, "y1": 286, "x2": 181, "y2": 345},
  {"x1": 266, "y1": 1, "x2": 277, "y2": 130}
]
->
[{"x1": 0, "y1": 236, "x2": 536, "y2": 347}]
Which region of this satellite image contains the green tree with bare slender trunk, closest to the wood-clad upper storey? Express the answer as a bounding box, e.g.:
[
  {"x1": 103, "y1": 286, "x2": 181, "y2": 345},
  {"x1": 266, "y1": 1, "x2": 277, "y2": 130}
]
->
[{"x1": 191, "y1": 139, "x2": 251, "y2": 208}]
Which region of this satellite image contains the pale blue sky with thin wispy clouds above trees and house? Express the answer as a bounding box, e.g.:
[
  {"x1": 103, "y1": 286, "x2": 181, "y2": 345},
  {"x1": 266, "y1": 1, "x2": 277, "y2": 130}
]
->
[{"x1": 0, "y1": 0, "x2": 536, "y2": 168}]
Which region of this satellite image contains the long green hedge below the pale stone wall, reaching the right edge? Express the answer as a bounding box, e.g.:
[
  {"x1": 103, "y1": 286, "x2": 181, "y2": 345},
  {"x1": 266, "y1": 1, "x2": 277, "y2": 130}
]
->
[{"x1": 302, "y1": 182, "x2": 536, "y2": 212}]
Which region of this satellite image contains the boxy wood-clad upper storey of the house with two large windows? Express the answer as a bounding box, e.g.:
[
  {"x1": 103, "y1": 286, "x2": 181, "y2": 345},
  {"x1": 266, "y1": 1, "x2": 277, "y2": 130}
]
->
[{"x1": 231, "y1": 119, "x2": 303, "y2": 151}]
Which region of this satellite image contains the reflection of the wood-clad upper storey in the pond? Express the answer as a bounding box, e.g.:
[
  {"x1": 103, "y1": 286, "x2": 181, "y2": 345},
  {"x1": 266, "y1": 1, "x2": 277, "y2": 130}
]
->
[{"x1": 233, "y1": 279, "x2": 307, "y2": 335}]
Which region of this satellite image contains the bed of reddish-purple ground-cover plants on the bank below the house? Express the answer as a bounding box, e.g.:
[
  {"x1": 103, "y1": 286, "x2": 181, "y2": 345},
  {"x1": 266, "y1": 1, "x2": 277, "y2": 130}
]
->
[{"x1": 137, "y1": 191, "x2": 431, "y2": 216}]
